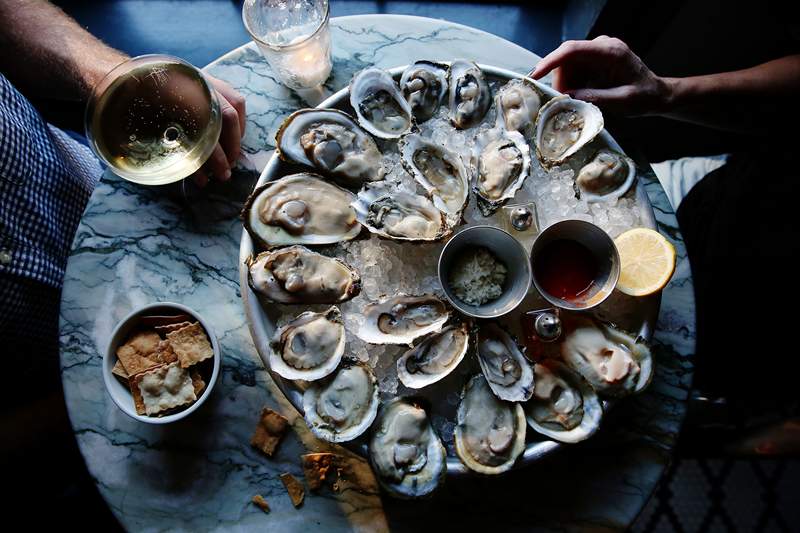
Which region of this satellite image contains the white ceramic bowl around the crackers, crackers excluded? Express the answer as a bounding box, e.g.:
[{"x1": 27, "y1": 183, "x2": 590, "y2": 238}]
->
[{"x1": 103, "y1": 302, "x2": 222, "y2": 424}]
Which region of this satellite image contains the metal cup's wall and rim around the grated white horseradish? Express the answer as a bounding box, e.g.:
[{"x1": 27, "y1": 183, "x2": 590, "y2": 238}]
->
[{"x1": 439, "y1": 226, "x2": 531, "y2": 318}]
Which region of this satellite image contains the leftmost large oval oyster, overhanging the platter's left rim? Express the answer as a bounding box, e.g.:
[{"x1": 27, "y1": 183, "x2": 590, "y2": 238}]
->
[{"x1": 242, "y1": 173, "x2": 361, "y2": 248}]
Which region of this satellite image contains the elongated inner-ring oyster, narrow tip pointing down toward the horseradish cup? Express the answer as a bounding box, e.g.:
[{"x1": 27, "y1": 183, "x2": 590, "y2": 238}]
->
[{"x1": 399, "y1": 134, "x2": 470, "y2": 220}]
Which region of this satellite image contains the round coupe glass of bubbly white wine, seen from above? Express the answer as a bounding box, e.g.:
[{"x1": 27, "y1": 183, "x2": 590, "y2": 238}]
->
[{"x1": 86, "y1": 55, "x2": 222, "y2": 185}]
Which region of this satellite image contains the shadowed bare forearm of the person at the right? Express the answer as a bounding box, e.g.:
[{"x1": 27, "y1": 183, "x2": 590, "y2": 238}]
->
[{"x1": 662, "y1": 55, "x2": 800, "y2": 133}]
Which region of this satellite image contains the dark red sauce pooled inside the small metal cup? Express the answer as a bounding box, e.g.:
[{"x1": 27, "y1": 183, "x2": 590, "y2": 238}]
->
[{"x1": 533, "y1": 239, "x2": 597, "y2": 301}]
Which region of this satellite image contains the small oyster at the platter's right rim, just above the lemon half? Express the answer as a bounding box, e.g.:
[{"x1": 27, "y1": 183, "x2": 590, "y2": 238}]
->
[{"x1": 575, "y1": 150, "x2": 636, "y2": 202}]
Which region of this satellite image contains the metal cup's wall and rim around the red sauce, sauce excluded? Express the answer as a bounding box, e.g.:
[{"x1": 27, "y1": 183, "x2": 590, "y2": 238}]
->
[{"x1": 531, "y1": 220, "x2": 619, "y2": 311}]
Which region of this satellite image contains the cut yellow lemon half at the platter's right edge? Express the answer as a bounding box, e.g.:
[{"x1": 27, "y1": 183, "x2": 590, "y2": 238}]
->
[{"x1": 614, "y1": 228, "x2": 675, "y2": 296}]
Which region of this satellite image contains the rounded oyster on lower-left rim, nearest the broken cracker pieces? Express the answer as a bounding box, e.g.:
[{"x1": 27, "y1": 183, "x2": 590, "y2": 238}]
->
[{"x1": 303, "y1": 360, "x2": 380, "y2": 442}]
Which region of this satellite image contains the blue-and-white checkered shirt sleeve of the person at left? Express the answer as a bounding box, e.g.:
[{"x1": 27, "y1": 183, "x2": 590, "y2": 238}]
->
[{"x1": 0, "y1": 74, "x2": 101, "y2": 287}]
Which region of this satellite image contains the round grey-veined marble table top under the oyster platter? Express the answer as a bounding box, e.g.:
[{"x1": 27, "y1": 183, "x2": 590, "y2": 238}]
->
[{"x1": 60, "y1": 15, "x2": 695, "y2": 531}]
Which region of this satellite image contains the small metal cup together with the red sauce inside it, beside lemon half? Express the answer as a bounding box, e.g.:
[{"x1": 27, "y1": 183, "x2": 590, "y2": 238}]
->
[{"x1": 531, "y1": 220, "x2": 619, "y2": 311}]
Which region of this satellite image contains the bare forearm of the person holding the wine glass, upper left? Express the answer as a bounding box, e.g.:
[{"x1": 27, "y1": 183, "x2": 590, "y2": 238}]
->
[{"x1": 0, "y1": 0, "x2": 126, "y2": 100}]
